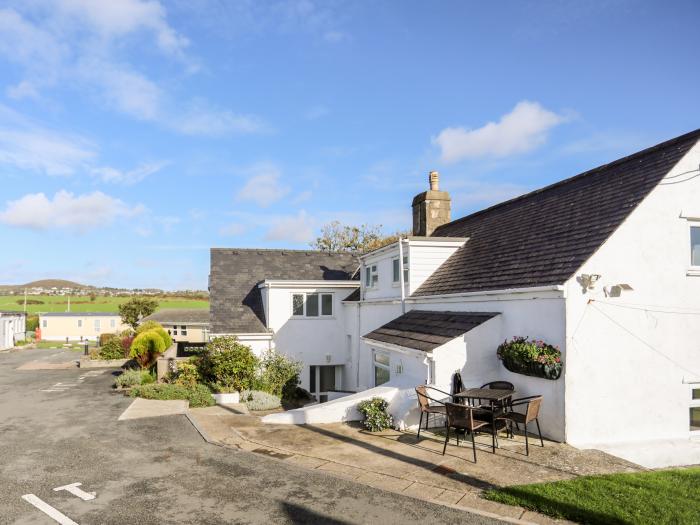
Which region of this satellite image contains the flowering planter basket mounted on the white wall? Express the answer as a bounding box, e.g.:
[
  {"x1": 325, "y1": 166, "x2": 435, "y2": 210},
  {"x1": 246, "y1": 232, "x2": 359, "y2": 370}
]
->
[{"x1": 496, "y1": 336, "x2": 562, "y2": 380}]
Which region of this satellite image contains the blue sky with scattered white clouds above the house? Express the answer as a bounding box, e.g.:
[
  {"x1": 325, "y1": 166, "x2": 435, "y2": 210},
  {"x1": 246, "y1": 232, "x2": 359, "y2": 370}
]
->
[{"x1": 0, "y1": 0, "x2": 700, "y2": 289}]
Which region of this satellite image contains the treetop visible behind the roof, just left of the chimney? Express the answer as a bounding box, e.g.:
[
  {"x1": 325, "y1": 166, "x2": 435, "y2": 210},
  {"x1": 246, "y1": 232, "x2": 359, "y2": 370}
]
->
[{"x1": 311, "y1": 221, "x2": 408, "y2": 253}]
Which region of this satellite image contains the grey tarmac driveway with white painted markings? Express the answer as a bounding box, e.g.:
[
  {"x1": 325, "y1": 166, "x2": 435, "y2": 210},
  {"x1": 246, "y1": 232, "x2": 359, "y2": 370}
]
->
[{"x1": 0, "y1": 350, "x2": 498, "y2": 525}]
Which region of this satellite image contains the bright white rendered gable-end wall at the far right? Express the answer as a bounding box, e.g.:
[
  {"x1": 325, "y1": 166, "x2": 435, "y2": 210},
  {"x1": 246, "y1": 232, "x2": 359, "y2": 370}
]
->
[{"x1": 566, "y1": 141, "x2": 700, "y2": 446}]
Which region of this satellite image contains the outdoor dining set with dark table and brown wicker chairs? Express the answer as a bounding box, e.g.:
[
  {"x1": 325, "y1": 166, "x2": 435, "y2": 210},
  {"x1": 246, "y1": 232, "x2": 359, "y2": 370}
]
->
[{"x1": 416, "y1": 381, "x2": 544, "y2": 462}]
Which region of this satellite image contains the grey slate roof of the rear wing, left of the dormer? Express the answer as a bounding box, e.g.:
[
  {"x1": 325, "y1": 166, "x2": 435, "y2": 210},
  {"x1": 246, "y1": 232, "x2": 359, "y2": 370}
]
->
[{"x1": 209, "y1": 248, "x2": 358, "y2": 334}]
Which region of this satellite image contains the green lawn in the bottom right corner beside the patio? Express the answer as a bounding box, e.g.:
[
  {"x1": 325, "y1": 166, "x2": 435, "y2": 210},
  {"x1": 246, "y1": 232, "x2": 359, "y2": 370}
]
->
[{"x1": 484, "y1": 467, "x2": 700, "y2": 525}]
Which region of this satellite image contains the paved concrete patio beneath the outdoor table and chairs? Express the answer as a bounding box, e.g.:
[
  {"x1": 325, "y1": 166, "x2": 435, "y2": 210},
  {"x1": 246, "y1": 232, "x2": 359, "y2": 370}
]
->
[{"x1": 189, "y1": 405, "x2": 642, "y2": 523}]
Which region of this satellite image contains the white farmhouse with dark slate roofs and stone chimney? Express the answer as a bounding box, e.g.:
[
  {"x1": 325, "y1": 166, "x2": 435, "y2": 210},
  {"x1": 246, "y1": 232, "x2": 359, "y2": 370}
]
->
[{"x1": 211, "y1": 130, "x2": 700, "y2": 458}]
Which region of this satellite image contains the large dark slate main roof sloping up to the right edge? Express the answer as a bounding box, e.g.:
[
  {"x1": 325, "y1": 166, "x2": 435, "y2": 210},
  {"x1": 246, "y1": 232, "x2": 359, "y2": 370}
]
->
[{"x1": 413, "y1": 129, "x2": 700, "y2": 296}]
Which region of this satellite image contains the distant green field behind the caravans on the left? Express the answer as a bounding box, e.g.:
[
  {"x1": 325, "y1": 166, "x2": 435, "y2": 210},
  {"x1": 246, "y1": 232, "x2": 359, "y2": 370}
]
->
[{"x1": 0, "y1": 295, "x2": 209, "y2": 313}]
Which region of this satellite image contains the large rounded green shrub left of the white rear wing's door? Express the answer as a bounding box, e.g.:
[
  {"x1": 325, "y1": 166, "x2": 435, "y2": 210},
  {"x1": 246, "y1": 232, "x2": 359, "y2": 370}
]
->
[{"x1": 199, "y1": 337, "x2": 258, "y2": 391}]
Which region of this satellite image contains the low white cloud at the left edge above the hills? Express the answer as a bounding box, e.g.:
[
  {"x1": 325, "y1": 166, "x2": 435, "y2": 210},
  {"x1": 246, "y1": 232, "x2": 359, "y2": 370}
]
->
[{"x1": 0, "y1": 190, "x2": 143, "y2": 232}]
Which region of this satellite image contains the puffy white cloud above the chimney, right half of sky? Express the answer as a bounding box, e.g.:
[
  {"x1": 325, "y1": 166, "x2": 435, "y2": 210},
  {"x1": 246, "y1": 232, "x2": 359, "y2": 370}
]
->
[{"x1": 432, "y1": 100, "x2": 566, "y2": 163}]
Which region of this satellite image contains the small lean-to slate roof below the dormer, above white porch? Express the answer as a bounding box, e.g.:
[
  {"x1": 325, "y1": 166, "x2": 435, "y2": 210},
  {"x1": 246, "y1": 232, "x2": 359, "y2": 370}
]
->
[{"x1": 365, "y1": 310, "x2": 498, "y2": 352}]
